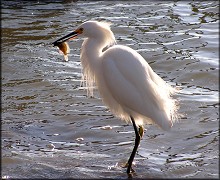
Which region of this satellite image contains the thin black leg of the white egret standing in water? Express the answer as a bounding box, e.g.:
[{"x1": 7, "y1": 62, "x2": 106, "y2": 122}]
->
[{"x1": 127, "y1": 116, "x2": 144, "y2": 174}]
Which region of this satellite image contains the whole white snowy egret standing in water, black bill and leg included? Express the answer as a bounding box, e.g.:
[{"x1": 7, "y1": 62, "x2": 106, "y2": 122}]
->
[{"x1": 53, "y1": 21, "x2": 178, "y2": 174}]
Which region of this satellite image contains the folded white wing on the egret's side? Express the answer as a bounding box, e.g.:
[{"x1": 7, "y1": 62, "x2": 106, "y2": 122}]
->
[{"x1": 102, "y1": 46, "x2": 173, "y2": 129}]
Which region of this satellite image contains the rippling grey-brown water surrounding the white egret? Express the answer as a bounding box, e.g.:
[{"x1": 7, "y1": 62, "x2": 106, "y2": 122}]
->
[{"x1": 1, "y1": 0, "x2": 219, "y2": 179}]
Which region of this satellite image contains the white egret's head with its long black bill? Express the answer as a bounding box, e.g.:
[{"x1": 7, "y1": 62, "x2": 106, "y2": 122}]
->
[{"x1": 52, "y1": 21, "x2": 114, "y2": 46}]
